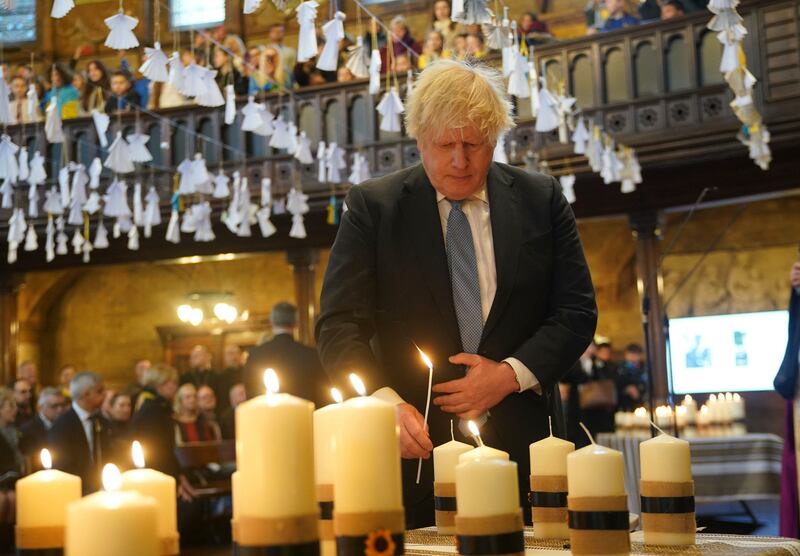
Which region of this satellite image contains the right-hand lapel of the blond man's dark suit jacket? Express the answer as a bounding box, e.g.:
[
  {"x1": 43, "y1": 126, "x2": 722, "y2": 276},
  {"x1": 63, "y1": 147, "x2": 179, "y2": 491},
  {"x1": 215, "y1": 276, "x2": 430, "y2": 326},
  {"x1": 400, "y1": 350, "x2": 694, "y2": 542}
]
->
[{"x1": 482, "y1": 163, "x2": 522, "y2": 340}]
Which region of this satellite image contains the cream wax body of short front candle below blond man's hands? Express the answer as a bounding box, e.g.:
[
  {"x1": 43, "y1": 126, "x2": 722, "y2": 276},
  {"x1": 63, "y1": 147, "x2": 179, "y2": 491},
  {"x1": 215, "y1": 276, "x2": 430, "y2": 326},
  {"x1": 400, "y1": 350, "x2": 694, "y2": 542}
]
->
[{"x1": 456, "y1": 458, "x2": 519, "y2": 518}]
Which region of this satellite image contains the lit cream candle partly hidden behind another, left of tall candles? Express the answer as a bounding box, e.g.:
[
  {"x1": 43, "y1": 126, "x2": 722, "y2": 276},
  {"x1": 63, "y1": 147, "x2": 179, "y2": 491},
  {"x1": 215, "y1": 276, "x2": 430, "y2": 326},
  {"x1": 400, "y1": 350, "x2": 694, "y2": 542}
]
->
[{"x1": 122, "y1": 441, "x2": 180, "y2": 554}]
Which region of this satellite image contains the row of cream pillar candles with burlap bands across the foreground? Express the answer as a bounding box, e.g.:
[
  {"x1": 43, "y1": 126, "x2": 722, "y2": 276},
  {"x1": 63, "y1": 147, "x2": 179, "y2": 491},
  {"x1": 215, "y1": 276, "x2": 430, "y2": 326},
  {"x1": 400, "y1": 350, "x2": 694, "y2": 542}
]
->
[{"x1": 17, "y1": 369, "x2": 694, "y2": 556}]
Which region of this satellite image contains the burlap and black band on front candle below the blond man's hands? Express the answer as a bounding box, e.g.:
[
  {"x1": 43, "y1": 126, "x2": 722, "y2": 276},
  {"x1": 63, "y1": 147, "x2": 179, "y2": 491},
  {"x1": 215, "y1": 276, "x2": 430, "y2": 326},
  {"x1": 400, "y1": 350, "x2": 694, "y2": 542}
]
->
[{"x1": 456, "y1": 510, "x2": 525, "y2": 556}]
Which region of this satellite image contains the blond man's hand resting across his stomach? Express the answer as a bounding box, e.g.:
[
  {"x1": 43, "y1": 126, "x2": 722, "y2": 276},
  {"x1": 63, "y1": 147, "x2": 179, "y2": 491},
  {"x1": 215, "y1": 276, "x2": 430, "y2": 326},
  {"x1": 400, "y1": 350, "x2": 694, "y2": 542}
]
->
[{"x1": 433, "y1": 353, "x2": 519, "y2": 419}]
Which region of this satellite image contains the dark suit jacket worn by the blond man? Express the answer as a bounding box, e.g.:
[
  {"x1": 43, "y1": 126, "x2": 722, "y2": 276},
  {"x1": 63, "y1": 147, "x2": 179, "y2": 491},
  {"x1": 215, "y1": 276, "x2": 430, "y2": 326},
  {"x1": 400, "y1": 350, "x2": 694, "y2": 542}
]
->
[{"x1": 317, "y1": 164, "x2": 597, "y2": 526}]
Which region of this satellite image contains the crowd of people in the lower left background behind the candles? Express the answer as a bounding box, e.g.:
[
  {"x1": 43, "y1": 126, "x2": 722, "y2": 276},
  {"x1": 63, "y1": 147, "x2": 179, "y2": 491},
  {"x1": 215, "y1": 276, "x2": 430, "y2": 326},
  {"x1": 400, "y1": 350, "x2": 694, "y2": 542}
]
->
[{"x1": 0, "y1": 302, "x2": 330, "y2": 542}]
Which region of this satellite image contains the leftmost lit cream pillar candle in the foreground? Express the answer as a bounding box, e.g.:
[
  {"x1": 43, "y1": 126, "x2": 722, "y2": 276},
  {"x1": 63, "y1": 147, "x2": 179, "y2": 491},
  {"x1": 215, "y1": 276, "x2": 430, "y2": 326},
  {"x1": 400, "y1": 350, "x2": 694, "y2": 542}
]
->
[{"x1": 15, "y1": 449, "x2": 81, "y2": 550}]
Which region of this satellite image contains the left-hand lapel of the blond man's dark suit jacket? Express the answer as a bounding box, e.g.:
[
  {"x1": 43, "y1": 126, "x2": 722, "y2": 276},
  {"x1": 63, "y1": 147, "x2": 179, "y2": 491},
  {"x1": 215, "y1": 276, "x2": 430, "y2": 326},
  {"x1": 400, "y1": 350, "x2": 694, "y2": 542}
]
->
[{"x1": 400, "y1": 164, "x2": 461, "y2": 346}]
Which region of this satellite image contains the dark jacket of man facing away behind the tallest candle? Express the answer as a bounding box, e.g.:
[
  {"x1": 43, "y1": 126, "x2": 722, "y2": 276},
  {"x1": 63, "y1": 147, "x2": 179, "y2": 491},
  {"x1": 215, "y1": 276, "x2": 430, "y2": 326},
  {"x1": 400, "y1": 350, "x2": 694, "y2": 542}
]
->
[{"x1": 244, "y1": 334, "x2": 333, "y2": 407}]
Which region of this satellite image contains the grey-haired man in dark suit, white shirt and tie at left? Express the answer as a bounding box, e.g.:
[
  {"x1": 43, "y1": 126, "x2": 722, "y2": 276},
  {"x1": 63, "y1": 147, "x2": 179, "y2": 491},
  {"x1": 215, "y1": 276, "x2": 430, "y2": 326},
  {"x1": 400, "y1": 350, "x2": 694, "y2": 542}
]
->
[{"x1": 47, "y1": 371, "x2": 113, "y2": 493}]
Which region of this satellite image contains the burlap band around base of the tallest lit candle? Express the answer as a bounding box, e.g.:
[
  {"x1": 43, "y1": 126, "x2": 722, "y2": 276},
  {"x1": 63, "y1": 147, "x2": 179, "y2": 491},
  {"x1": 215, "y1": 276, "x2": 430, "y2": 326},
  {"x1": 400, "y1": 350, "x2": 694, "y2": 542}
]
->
[{"x1": 237, "y1": 514, "x2": 319, "y2": 546}]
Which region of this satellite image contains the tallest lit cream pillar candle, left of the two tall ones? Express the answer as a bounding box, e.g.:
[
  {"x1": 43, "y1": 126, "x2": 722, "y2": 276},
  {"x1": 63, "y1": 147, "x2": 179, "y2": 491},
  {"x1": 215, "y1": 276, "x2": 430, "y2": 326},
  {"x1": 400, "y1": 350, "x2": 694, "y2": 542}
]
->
[{"x1": 236, "y1": 370, "x2": 319, "y2": 546}]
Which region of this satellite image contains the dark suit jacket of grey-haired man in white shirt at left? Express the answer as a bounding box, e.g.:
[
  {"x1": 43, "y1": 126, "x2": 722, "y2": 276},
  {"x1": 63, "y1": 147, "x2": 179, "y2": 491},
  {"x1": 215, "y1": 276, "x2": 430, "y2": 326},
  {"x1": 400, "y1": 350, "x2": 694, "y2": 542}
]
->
[{"x1": 47, "y1": 408, "x2": 117, "y2": 494}]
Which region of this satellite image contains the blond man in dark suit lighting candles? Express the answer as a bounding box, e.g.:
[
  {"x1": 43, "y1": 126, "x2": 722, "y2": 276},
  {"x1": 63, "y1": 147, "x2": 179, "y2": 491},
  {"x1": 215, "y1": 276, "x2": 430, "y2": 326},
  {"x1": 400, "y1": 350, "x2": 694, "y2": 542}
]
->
[{"x1": 317, "y1": 60, "x2": 597, "y2": 527}]
